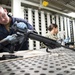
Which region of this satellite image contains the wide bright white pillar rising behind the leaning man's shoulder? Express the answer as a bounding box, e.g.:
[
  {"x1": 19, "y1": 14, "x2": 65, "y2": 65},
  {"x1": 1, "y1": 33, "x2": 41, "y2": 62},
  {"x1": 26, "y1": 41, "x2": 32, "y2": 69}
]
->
[{"x1": 11, "y1": 0, "x2": 24, "y2": 18}]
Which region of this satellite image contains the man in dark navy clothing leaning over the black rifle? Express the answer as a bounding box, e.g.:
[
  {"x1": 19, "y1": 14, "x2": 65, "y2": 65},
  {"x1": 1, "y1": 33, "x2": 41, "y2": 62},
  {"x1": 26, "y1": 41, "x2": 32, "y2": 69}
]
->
[{"x1": 0, "y1": 6, "x2": 33, "y2": 52}]
